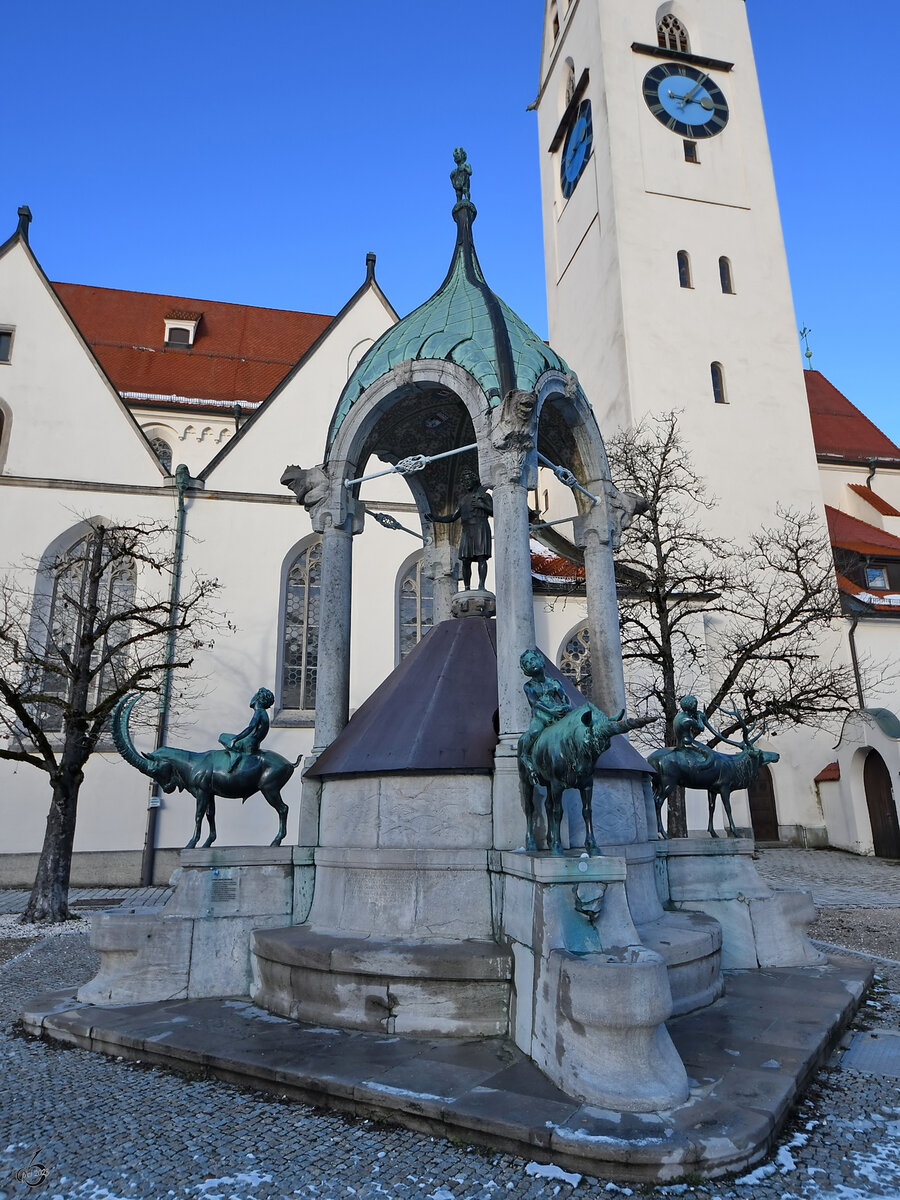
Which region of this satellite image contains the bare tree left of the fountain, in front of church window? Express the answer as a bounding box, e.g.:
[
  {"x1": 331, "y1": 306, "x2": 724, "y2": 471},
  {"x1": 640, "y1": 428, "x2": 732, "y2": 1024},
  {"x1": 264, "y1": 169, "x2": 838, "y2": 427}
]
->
[{"x1": 0, "y1": 521, "x2": 224, "y2": 923}]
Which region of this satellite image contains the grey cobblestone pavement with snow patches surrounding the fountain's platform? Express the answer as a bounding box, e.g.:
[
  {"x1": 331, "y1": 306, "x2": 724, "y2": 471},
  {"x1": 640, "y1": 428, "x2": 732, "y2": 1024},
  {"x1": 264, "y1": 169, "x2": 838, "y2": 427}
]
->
[{"x1": 0, "y1": 851, "x2": 900, "y2": 1200}]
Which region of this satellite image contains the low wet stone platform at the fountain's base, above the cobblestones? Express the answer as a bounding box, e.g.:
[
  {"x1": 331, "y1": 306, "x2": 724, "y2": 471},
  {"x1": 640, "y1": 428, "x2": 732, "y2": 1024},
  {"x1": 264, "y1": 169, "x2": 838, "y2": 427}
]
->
[{"x1": 23, "y1": 959, "x2": 871, "y2": 1181}]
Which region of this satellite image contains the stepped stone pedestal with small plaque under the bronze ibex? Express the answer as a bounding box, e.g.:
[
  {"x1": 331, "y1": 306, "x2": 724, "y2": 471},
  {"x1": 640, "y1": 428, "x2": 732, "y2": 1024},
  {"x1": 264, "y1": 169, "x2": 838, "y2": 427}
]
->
[{"x1": 78, "y1": 846, "x2": 313, "y2": 1004}]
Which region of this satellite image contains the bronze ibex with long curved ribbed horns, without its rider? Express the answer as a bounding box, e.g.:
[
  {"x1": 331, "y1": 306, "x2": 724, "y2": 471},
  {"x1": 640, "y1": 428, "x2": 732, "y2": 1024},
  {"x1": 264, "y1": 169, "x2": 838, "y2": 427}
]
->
[{"x1": 112, "y1": 695, "x2": 302, "y2": 850}]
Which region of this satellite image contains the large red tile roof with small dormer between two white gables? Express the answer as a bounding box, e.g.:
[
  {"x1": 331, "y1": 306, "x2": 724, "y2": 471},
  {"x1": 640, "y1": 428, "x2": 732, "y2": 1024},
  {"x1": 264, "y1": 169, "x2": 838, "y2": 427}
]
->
[{"x1": 53, "y1": 283, "x2": 332, "y2": 403}]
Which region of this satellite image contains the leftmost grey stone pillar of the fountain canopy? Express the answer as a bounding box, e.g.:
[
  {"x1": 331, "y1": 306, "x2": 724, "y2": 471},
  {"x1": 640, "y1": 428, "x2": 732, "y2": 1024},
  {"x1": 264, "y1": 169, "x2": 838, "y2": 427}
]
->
[{"x1": 312, "y1": 520, "x2": 353, "y2": 755}]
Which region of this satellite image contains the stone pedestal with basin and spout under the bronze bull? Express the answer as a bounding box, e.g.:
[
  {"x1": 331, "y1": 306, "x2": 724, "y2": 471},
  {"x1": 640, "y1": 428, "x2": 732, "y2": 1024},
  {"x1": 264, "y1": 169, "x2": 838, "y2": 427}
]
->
[{"x1": 491, "y1": 851, "x2": 689, "y2": 1112}]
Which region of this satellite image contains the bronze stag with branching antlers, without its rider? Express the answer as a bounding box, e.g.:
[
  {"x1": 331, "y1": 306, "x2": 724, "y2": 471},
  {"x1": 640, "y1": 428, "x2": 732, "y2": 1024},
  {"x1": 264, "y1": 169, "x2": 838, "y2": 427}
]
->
[{"x1": 647, "y1": 697, "x2": 779, "y2": 838}]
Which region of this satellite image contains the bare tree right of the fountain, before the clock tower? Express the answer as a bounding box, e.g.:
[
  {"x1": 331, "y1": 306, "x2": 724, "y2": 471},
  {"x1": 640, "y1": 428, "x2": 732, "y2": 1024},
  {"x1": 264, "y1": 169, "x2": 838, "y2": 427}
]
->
[{"x1": 607, "y1": 413, "x2": 859, "y2": 836}]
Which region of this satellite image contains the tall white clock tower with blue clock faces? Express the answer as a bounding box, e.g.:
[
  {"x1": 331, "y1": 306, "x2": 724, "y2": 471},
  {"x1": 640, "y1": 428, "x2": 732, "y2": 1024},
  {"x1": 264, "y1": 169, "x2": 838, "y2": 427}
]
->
[{"x1": 538, "y1": 0, "x2": 821, "y2": 536}]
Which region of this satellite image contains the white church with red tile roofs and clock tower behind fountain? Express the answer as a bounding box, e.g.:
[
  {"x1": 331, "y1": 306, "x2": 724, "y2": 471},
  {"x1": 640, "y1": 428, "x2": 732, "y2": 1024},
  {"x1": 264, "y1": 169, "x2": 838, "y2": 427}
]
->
[{"x1": 0, "y1": 0, "x2": 900, "y2": 886}]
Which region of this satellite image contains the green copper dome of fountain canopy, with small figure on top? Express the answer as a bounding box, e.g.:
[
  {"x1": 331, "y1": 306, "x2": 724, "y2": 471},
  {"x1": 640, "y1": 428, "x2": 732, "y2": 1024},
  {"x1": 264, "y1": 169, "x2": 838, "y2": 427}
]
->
[{"x1": 328, "y1": 151, "x2": 569, "y2": 448}]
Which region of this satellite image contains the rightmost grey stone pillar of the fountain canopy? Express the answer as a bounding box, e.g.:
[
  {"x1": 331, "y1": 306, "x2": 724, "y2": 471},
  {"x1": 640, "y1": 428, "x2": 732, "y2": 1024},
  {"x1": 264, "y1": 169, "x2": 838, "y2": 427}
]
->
[{"x1": 575, "y1": 496, "x2": 625, "y2": 715}]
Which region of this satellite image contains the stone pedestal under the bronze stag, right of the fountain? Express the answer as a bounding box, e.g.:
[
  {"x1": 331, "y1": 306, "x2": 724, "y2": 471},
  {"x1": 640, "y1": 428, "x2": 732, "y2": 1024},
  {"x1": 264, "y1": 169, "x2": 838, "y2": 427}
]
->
[{"x1": 656, "y1": 838, "x2": 826, "y2": 970}]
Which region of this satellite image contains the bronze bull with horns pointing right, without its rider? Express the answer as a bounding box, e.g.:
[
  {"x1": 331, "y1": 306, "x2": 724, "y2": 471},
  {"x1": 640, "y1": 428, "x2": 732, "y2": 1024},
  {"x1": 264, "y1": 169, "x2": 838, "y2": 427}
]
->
[{"x1": 518, "y1": 703, "x2": 656, "y2": 854}]
